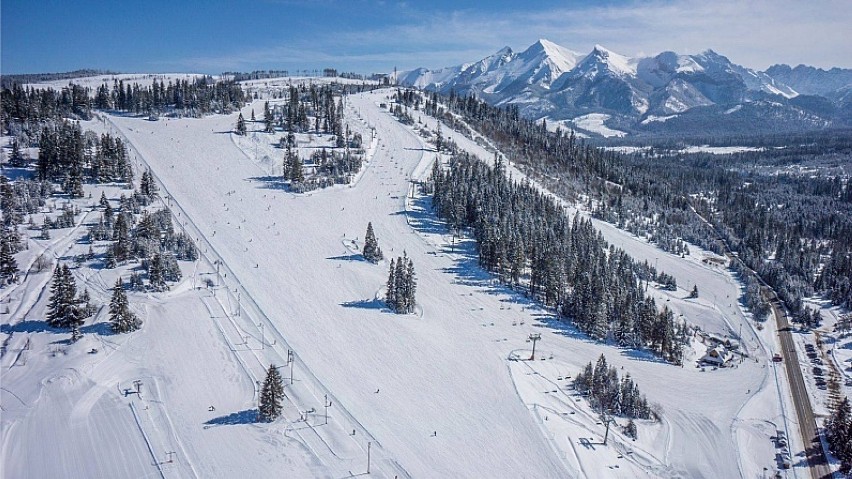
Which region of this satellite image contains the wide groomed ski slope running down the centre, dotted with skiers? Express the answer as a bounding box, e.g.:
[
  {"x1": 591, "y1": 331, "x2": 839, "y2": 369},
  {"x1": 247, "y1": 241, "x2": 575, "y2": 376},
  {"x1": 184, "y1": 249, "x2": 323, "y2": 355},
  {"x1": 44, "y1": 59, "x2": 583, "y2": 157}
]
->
[{"x1": 106, "y1": 92, "x2": 564, "y2": 477}]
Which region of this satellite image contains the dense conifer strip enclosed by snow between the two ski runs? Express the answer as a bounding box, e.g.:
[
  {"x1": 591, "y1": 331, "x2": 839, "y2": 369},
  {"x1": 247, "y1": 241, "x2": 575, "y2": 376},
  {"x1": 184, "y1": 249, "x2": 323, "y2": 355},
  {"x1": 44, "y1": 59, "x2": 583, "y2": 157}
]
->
[{"x1": 430, "y1": 153, "x2": 691, "y2": 364}]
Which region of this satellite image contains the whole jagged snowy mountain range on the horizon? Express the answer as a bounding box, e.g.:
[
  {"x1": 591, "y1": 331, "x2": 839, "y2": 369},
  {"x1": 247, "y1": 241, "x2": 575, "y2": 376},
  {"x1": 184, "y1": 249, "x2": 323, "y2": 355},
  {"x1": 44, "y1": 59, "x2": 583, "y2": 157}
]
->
[{"x1": 396, "y1": 39, "x2": 852, "y2": 136}]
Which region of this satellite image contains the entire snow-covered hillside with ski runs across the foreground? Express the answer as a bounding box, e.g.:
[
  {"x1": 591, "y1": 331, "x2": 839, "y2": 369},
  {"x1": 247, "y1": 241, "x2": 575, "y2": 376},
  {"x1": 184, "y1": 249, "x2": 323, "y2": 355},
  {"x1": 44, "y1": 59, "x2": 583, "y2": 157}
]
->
[{"x1": 0, "y1": 85, "x2": 820, "y2": 478}]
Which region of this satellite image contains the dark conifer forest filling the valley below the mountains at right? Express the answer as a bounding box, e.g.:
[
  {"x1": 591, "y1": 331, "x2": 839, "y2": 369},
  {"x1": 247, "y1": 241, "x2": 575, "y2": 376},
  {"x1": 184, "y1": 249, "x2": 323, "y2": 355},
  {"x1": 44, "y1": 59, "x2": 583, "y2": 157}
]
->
[{"x1": 404, "y1": 90, "x2": 852, "y2": 324}]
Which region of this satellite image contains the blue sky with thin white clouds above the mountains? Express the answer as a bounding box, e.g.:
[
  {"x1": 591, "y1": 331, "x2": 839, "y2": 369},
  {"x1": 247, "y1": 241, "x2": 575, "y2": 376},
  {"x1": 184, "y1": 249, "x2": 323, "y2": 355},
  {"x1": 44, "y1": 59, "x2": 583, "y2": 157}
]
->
[{"x1": 0, "y1": 0, "x2": 852, "y2": 73}]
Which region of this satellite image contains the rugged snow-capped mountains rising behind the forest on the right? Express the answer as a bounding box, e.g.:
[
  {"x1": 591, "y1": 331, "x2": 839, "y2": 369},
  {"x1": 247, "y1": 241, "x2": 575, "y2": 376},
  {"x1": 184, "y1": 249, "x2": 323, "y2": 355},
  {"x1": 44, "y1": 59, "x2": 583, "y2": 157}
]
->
[{"x1": 400, "y1": 39, "x2": 852, "y2": 137}]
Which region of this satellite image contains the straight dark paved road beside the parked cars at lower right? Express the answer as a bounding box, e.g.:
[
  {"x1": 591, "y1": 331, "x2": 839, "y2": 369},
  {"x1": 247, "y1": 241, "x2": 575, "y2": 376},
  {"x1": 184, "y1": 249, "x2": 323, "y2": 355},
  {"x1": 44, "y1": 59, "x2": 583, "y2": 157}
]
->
[{"x1": 764, "y1": 287, "x2": 832, "y2": 479}]
